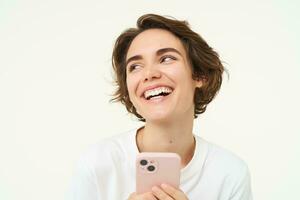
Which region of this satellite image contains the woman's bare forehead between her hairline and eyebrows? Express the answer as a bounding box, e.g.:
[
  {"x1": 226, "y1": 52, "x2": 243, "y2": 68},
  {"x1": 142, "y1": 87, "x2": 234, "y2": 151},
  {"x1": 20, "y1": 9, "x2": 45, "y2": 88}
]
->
[{"x1": 126, "y1": 29, "x2": 185, "y2": 59}]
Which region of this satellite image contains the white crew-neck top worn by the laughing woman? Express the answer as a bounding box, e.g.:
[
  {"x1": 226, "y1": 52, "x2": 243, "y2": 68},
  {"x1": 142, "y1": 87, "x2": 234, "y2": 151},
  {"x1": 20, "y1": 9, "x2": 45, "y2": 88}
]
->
[{"x1": 67, "y1": 129, "x2": 252, "y2": 200}]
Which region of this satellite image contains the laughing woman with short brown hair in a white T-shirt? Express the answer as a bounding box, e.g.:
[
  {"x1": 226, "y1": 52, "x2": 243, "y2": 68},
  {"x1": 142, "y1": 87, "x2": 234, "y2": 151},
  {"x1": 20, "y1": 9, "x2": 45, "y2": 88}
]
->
[{"x1": 71, "y1": 14, "x2": 252, "y2": 200}]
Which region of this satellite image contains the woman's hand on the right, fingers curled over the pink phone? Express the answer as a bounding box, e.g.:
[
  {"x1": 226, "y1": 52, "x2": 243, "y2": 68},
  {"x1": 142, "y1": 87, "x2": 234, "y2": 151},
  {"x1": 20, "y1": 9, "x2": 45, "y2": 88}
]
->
[{"x1": 152, "y1": 184, "x2": 188, "y2": 200}]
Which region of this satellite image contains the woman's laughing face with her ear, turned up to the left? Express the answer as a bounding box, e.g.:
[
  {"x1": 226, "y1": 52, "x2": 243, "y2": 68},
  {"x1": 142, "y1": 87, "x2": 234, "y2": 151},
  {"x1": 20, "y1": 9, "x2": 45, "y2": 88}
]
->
[{"x1": 126, "y1": 29, "x2": 202, "y2": 122}]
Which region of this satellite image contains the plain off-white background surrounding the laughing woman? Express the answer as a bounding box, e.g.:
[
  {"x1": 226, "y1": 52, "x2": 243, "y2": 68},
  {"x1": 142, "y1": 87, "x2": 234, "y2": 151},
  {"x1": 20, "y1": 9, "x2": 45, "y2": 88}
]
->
[{"x1": 0, "y1": 0, "x2": 300, "y2": 200}]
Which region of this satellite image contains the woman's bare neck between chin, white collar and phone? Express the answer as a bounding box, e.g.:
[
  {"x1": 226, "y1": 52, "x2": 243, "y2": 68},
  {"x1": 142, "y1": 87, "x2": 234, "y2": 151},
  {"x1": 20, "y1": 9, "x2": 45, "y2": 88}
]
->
[{"x1": 136, "y1": 116, "x2": 195, "y2": 167}]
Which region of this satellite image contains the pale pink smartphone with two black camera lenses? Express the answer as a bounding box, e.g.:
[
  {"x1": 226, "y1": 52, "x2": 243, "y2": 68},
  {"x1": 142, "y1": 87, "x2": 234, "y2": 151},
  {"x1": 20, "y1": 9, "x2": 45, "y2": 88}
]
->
[{"x1": 136, "y1": 152, "x2": 181, "y2": 194}]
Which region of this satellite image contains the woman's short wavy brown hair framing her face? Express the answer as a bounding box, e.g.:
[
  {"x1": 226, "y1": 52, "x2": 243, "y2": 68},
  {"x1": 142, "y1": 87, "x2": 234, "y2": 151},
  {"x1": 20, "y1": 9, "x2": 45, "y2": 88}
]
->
[{"x1": 111, "y1": 14, "x2": 224, "y2": 121}]
